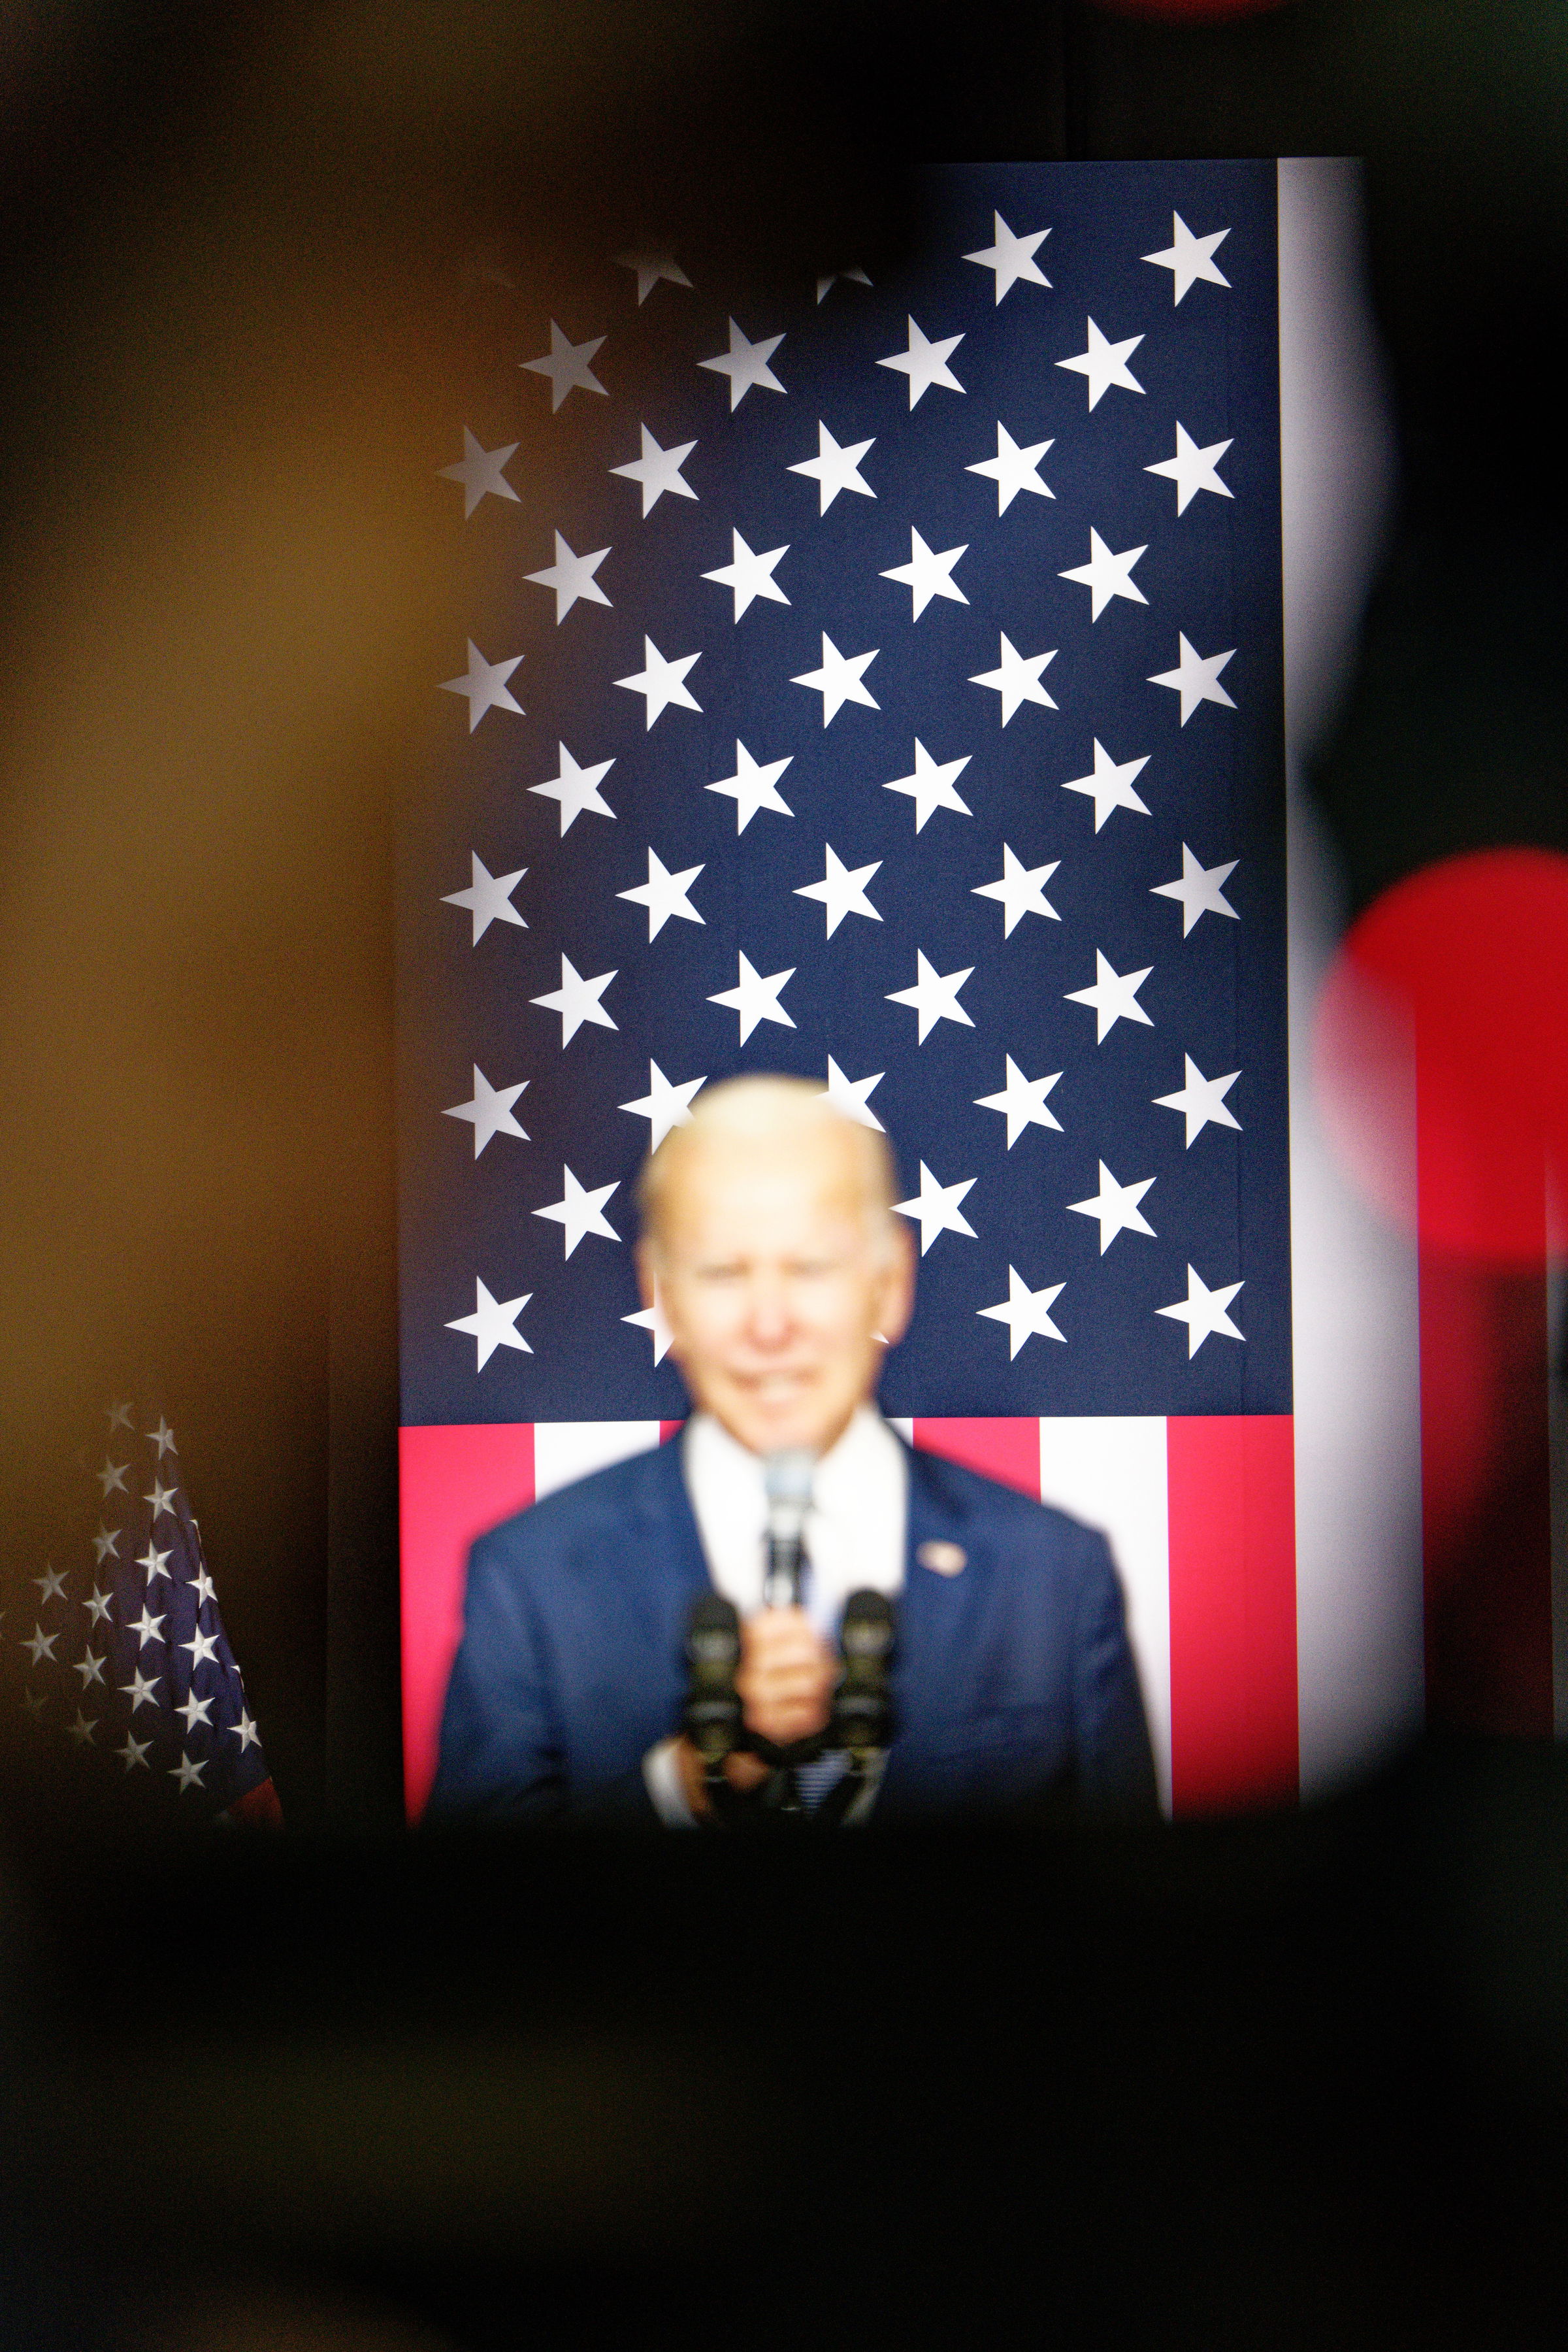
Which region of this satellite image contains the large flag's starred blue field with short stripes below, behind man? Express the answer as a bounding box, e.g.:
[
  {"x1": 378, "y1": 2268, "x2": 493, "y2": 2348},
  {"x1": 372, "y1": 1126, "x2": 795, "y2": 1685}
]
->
[{"x1": 400, "y1": 162, "x2": 1382, "y2": 1814}]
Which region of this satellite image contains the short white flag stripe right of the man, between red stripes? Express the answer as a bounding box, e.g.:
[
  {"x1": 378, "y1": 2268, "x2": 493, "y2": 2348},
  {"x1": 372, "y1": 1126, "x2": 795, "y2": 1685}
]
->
[{"x1": 1039, "y1": 1414, "x2": 1171, "y2": 1814}]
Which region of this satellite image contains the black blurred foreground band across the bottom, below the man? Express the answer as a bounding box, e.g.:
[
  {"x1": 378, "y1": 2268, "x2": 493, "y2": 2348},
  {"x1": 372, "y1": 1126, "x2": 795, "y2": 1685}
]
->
[{"x1": 5, "y1": 1747, "x2": 1568, "y2": 2352}]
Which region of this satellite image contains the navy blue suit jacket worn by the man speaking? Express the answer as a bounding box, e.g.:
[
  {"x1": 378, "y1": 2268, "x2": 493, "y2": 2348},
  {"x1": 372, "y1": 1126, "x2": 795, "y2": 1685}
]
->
[{"x1": 430, "y1": 1444, "x2": 1154, "y2": 1821}]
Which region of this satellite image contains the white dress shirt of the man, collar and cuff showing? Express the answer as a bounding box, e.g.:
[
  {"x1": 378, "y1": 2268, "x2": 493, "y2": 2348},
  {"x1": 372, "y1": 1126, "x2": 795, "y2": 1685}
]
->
[{"x1": 642, "y1": 1404, "x2": 910, "y2": 1827}]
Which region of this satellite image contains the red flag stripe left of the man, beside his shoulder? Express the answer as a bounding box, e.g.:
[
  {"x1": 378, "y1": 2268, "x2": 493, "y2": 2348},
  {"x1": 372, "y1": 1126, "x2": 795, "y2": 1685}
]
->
[{"x1": 400, "y1": 1421, "x2": 534, "y2": 1821}]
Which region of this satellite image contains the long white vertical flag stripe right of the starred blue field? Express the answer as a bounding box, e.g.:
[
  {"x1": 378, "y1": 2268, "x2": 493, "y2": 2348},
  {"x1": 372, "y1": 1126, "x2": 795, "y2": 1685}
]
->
[{"x1": 1279, "y1": 157, "x2": 1422, "y2": 1797}]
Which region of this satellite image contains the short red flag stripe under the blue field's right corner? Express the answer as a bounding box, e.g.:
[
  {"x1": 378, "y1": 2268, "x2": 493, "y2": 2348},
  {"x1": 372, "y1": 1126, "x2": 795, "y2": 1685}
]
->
[{"x1": 1166, "y1": 1414, "x2": 1300, "y2": 1814}]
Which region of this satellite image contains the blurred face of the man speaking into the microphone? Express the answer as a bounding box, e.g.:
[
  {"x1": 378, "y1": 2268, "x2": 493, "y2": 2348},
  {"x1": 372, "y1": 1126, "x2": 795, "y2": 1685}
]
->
[{"x1": 642, "y1": 1122, "x2": 915, "y2": 1453}]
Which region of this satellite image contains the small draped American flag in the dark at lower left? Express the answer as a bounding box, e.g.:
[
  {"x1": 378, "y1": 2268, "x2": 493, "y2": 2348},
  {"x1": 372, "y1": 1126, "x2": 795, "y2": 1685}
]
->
[{"x1": 7, "y1": 1399, "x2": 272, "y2": 1815}]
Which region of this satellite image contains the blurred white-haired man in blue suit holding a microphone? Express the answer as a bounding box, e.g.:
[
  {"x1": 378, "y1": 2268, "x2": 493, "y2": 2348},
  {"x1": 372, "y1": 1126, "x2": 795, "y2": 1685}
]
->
[{"x1": 430, "y1": 1077, "x2": 1154, "y2": 1827}]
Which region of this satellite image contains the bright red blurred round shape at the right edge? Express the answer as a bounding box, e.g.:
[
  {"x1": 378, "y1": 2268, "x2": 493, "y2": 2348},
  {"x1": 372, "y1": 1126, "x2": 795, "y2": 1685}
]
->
[{"x1": 1314, "y1": 849, "x2": 1568, "y2": 1268}]
